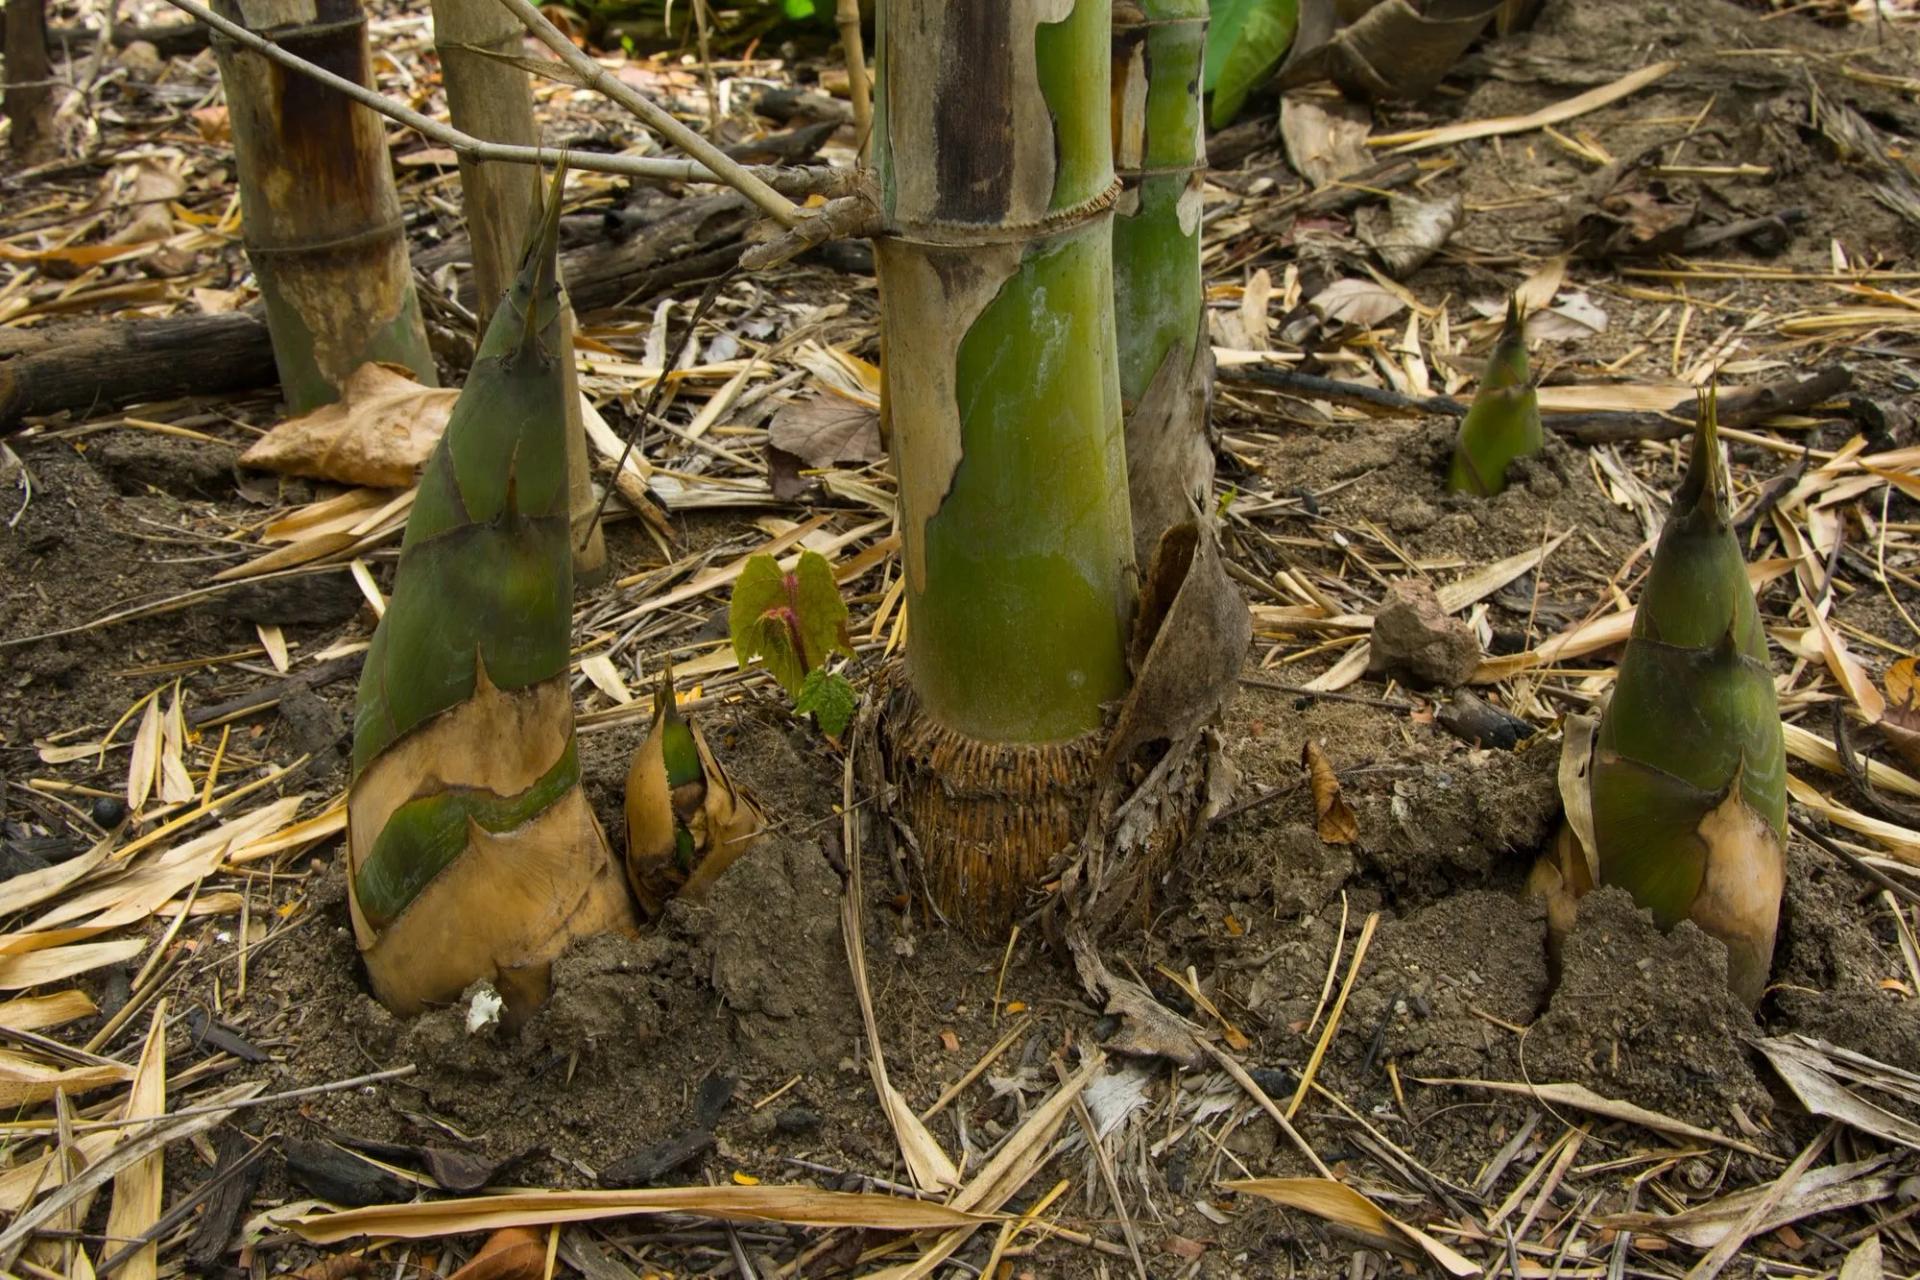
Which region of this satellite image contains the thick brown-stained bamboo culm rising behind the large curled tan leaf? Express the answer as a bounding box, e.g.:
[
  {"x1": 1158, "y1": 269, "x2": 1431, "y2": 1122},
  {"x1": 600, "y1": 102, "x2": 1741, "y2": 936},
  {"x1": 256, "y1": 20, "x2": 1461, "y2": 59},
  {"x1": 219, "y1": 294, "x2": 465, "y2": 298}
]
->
[{"x1": 215, "y1": 0, "x2": 436, "y2": 413}]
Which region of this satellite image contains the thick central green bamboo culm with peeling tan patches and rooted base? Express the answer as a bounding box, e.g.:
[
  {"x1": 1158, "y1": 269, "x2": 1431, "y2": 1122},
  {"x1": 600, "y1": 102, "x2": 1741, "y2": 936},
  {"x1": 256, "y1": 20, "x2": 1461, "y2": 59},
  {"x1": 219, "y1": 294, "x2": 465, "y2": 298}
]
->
[{"x1": 874, "y1": 0, "x2": 1135, "y2": 925}]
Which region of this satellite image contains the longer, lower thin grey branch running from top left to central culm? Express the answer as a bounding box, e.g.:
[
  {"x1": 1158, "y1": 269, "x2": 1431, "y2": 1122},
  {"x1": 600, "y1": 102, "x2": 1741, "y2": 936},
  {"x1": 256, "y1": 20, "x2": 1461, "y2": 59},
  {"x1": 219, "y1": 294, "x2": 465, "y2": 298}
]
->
[{"x1": 167, "y1": 0, "x2": 820, "y2": 195}]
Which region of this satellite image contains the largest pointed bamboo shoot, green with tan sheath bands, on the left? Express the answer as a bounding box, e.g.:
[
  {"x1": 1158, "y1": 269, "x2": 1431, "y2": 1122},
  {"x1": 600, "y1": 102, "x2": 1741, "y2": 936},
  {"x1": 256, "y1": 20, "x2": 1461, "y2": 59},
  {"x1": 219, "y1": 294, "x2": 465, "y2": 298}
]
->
[{"x1": 348, "y1": 180, "x2": 636, "y2": 1021}]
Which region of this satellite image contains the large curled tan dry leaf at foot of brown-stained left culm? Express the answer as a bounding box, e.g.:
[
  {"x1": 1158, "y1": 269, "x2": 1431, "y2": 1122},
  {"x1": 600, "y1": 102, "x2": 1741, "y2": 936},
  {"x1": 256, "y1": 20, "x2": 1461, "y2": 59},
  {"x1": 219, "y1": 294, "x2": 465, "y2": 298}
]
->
[{"x1": 240, "y1": 363, "x2": 459, "y2": 489}]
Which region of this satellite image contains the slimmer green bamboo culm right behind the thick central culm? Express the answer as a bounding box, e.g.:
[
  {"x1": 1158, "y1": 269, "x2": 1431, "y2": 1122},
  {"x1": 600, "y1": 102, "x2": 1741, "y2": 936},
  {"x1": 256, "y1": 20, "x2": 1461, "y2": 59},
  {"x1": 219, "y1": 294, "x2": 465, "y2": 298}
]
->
[{"x1": 1112, "y1": 0, "x2": 1213, "y2": 566}]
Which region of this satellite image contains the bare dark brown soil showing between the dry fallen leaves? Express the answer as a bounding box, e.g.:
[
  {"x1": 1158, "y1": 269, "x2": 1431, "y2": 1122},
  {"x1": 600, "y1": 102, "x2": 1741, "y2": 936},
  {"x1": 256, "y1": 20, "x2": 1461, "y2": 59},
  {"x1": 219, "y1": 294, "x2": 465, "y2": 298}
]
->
[{"x1": 0, "y1": 0, "x2": 1920, "y2": 1278}]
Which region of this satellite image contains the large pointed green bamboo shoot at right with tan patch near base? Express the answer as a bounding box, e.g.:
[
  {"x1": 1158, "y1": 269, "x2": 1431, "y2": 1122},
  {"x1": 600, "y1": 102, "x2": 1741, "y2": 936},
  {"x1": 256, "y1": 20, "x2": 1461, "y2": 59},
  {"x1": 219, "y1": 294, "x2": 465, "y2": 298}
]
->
[{"x1": 1592, "y1": 391, "x2": 1788, "y2": 1004}]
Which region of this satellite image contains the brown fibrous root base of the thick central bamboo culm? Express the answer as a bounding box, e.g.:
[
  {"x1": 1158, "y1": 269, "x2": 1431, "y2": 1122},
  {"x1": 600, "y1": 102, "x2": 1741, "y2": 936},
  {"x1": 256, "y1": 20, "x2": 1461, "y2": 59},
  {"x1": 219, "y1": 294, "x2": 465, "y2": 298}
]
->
[{"x1": 876, "y1": 664, "x2": 1106, "y2": 936}]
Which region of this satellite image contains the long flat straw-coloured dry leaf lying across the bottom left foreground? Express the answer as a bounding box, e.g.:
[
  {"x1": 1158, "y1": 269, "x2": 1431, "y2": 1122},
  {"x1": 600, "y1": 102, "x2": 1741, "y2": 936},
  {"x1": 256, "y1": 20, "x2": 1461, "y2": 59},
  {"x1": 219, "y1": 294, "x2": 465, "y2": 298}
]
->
[{"x1": 288, "y1": 1186, "x2": 989, "y2": 1244}]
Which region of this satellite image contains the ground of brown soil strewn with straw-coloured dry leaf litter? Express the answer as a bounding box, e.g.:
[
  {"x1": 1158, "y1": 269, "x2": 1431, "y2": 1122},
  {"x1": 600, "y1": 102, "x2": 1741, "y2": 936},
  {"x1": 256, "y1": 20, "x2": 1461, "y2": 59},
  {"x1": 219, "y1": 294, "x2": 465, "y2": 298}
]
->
[{"x1": 0, "y1": 0, "x2": 1920, "y2": 1276}]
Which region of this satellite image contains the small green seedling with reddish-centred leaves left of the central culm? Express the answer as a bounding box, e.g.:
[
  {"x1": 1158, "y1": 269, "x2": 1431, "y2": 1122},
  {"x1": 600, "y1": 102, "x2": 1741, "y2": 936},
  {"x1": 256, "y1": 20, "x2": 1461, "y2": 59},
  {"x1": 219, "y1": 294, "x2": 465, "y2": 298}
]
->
[{"x1": 728, "y1": 551, "x2": 854, "y2": 737}]
